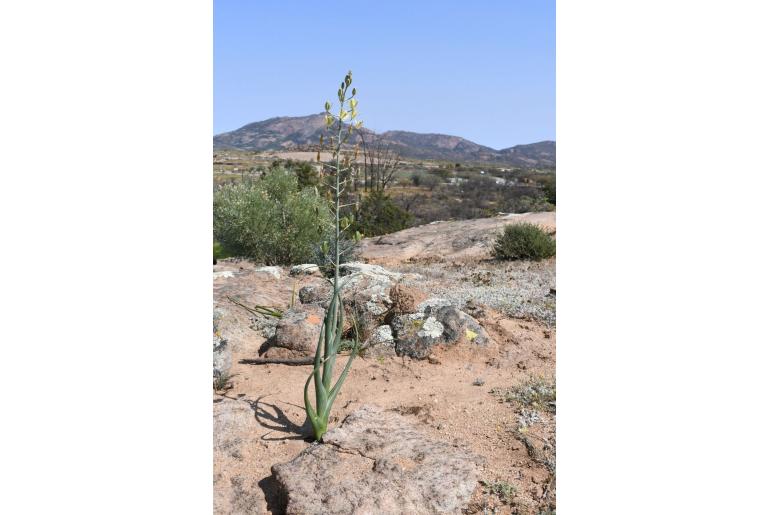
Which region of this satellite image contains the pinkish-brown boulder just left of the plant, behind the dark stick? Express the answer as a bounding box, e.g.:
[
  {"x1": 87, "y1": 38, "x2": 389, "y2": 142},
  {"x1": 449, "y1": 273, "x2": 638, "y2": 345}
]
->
[{"x1": 270, "y1": 304, "x2": 324, "y2": 357}]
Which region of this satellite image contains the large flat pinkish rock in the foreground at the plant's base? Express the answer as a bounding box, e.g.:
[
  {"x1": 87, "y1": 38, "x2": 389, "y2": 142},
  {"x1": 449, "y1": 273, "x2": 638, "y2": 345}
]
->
[{"x1": 272, "y1": 406, "x2": 481, "y2": 515}]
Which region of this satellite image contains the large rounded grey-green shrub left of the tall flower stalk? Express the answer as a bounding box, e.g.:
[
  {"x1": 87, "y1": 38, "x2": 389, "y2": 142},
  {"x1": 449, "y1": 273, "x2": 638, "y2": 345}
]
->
[{"x1": 214, "y1": 168, "x2": 332, "y2": 265}]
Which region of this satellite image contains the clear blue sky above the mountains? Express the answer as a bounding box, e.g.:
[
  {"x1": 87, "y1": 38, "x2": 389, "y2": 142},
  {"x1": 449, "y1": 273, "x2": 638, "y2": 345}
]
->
[{"x1": 214, "y1": 0, "x2": 556, "y2": 148}]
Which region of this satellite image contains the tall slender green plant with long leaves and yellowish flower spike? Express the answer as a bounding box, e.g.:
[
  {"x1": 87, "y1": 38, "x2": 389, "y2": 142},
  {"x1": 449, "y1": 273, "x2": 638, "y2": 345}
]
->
[{"x1": 304, "y1": 72, "x2": 363, "y2": 441}]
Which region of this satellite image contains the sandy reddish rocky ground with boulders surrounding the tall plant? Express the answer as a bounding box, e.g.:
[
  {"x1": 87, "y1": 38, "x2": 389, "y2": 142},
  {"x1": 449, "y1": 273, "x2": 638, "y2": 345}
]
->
[{"x1": 213, "y1": 213, "x2": 556, "y2": 513}]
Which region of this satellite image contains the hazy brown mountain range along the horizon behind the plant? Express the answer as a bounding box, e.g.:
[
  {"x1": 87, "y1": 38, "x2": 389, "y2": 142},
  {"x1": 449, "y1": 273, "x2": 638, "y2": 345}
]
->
[{"x1": 214, "y1": 113, "x2": 556, "y2": 168}]
